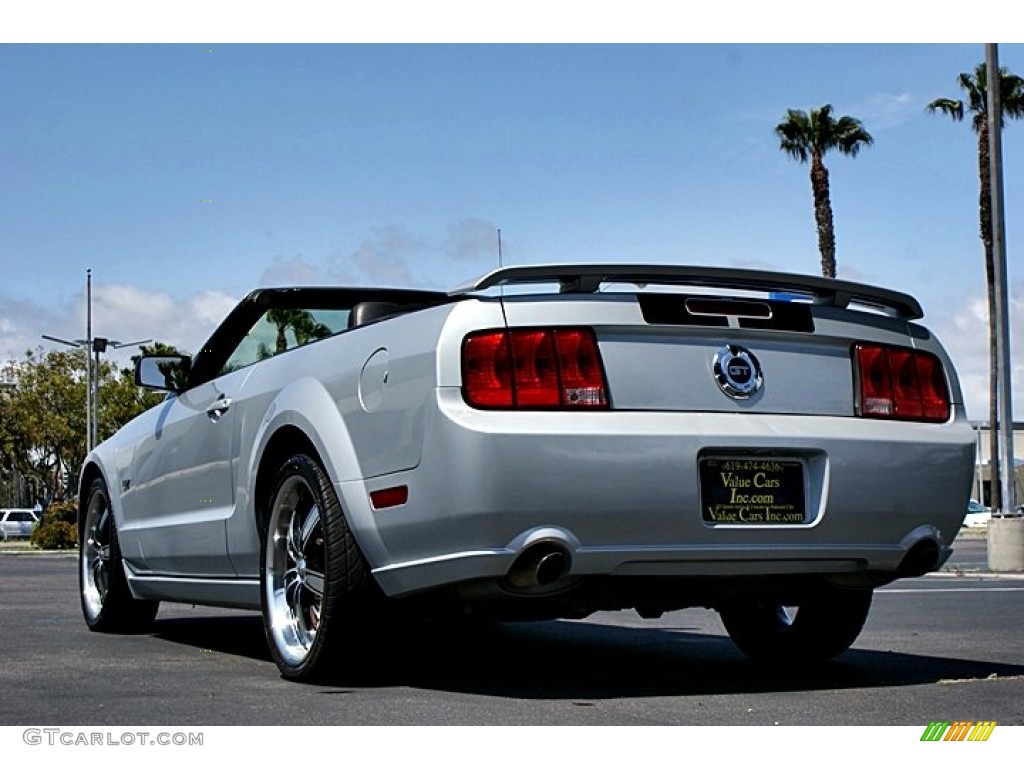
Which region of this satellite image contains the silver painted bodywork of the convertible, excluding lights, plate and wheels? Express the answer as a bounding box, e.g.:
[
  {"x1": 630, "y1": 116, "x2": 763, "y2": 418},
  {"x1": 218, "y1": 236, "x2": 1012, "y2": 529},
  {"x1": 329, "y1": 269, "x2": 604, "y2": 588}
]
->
[{"x1": 83, "y1": 270, "x2": 975, "y2": 608}]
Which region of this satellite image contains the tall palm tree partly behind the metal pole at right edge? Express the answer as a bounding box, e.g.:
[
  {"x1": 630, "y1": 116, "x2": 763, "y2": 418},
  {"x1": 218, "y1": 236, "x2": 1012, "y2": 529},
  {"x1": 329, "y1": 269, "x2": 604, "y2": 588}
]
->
[{"x1": 928, "y1": 63, "x2": 1024, "y2": 509}]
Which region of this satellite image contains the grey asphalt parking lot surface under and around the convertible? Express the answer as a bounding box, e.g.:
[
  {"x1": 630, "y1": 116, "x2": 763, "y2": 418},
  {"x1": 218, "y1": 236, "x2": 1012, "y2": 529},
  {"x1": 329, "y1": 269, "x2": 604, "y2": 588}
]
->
[{"x1": 0, "y1": 535, "x2": 1024, "y2": 727}]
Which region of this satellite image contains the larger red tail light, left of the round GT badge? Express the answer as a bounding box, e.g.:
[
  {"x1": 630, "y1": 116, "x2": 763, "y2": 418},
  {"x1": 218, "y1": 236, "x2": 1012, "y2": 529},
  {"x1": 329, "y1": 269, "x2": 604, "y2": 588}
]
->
[{"x1": 462, "y1": 328, "x2": 608, "y2": 409}]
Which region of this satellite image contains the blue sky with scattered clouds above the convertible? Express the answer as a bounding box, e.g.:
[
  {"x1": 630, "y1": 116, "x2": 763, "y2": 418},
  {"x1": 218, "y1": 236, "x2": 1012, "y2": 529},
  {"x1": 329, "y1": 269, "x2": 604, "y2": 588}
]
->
[{"x1": 0, "y1": 42, "x2": 1024, "y2": 419}]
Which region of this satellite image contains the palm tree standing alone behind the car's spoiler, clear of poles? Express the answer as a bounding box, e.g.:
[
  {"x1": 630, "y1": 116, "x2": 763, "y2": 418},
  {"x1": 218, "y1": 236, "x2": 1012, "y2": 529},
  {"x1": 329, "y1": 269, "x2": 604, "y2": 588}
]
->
[{"x1": 775, "y1": 104, "x2": 874, "y2": 278}]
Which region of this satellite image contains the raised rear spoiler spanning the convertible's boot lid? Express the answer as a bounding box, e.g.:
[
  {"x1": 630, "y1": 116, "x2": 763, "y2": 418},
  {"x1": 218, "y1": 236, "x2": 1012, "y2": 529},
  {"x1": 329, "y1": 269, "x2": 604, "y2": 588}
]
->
[{"x1": 450, "y1": 264, "x2": 925, "y2": 321}]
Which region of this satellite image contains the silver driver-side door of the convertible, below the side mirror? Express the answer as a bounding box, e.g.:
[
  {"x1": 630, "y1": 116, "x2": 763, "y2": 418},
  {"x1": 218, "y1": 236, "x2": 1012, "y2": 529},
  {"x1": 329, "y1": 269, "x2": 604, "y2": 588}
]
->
[{"x1": 121, "y1": 369, "x2": 251, "y2": 577}]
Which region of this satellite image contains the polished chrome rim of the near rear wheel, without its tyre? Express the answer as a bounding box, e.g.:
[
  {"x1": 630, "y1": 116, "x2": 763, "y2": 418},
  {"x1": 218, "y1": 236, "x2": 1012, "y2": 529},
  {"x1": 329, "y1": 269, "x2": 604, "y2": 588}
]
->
[{"x1": 263, "y1": 475, "x2": 326, "y2": 665}]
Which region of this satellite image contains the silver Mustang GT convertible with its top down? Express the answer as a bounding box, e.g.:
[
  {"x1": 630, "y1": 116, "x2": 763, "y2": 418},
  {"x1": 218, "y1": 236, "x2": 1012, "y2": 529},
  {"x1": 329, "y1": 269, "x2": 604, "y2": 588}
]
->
[{"x1": 79, "y1": 264, "x2": 975, "y2": 680}]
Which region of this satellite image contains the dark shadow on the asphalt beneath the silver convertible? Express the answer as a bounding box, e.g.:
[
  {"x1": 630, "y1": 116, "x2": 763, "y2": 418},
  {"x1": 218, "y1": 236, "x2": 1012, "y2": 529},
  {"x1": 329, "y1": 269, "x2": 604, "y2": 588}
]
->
[{"x1": 146, "y1": 614, "x2": 1024, "y2": 699}]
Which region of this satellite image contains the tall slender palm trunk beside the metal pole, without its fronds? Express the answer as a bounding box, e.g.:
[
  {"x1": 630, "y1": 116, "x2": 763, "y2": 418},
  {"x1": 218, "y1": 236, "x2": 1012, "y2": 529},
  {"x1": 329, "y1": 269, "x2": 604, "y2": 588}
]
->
[{"x1": 978, "y1": 120, "x2": 1010, "y2": 510}]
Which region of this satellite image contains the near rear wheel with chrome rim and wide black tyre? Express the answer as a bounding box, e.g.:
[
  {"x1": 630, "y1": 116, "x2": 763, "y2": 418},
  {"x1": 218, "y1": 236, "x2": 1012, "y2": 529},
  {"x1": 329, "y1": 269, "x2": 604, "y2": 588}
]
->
[{"x1": 260, "y1": 455, "x2": 377, "y2": 681}]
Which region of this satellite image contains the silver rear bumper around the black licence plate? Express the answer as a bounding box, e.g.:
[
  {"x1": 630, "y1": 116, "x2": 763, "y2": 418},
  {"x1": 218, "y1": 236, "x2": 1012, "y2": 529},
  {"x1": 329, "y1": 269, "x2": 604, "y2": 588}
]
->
[{"x1": 360, "y1": 388, "x2": 975, "y2": 595}]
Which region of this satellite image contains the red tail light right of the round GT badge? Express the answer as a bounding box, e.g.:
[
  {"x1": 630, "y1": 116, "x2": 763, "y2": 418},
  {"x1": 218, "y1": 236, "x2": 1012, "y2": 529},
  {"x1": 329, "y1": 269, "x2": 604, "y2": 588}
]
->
[{"x1": 854, "y1": 344, "x2": 950, "y2": 422}]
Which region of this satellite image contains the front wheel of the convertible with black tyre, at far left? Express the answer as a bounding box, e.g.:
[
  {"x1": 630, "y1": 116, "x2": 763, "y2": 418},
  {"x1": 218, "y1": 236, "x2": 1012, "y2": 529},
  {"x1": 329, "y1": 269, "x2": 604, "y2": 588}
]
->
[{"x1": 78, "y1": 477, "x2": 160, "y2": 633}]
